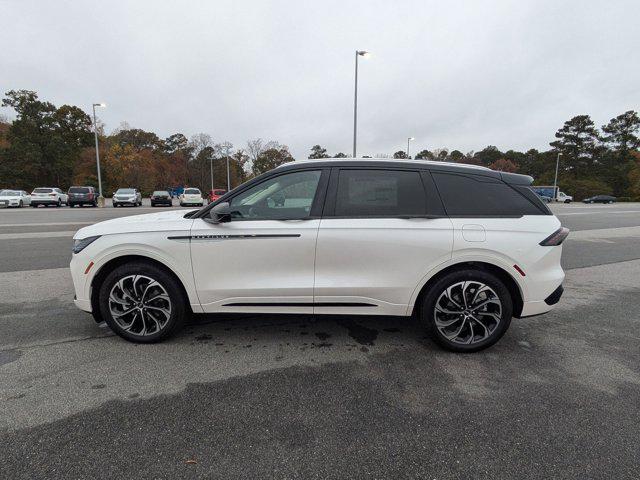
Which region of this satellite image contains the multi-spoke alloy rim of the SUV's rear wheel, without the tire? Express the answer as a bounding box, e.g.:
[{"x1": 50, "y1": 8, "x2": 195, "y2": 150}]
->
[{"x1": 433, "y1": 280, "x2": 502, "y2": 345}]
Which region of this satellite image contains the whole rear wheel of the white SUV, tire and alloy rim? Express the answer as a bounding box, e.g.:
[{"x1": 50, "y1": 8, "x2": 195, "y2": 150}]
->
[{"x1": 422, "y1": 270, "x2": 513, "y2": 352}]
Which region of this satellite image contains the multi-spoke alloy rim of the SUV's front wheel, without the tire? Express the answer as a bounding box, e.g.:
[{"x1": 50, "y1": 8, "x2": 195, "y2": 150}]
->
[{"x1": 108, "y1": 275, "x2": 171, "y2": 336}]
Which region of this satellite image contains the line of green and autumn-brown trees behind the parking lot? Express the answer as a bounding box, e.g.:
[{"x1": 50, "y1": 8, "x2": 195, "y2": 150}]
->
[{"x1": 0, "y1": 90, "x2": 640, "y2": 200}]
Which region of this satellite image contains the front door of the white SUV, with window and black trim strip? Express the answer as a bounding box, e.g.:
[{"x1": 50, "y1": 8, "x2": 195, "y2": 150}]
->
[{"x1": 191, "y1": 169, "x2": 328, "y2": 313}]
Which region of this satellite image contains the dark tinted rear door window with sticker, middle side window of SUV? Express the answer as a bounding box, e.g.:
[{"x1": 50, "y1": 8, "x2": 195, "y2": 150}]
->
[{"x1": 335, "y1": 170, "x2": 427, "y2": 217}]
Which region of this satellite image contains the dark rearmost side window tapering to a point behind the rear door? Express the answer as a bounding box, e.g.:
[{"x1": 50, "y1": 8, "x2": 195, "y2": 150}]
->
[{"x1": 432, "y1": 172, "x2": 546, "y2": 217}]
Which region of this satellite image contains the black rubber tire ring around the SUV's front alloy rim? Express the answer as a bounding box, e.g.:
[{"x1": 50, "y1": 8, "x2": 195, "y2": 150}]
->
[{"x1": 99, "y1": 262, "x2": 187, "y2": 343}]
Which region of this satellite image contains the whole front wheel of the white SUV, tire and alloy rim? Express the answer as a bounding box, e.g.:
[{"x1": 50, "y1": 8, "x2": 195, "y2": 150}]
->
[{"x1": 99, "y1": 263, "x2": 186, "y2": 343}]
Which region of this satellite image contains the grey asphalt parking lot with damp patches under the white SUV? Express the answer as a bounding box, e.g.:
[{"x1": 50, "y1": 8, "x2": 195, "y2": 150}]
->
[{"x1": 0, "y1": 203, "x2": 640, "y2": 479}]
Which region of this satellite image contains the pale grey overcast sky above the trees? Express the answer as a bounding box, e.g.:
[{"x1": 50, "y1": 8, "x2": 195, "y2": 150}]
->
[{"x1": 0, "y1": 0, "x2": 640, "y2": 158}]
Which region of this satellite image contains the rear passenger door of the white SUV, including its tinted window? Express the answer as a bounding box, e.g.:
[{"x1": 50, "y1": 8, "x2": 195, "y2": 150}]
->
[{"x1": 314, "y1": 167, "x2": 453, "y2": 315}]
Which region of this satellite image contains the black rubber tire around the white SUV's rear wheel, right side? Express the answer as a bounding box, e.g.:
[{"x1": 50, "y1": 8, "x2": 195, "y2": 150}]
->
[{"x1": 421, "y1": 269, "x2": 513, "y2": 353}]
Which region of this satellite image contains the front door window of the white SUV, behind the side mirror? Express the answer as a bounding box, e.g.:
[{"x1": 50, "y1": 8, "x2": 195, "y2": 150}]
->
[{"x1": 229, "y1": 170, "x2": 322, "y2": 220}]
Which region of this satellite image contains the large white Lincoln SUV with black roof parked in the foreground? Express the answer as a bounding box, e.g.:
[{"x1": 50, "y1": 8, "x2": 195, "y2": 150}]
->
[{"x1": 71, "y1": 159, "x2": 568, "y2": 351}]
